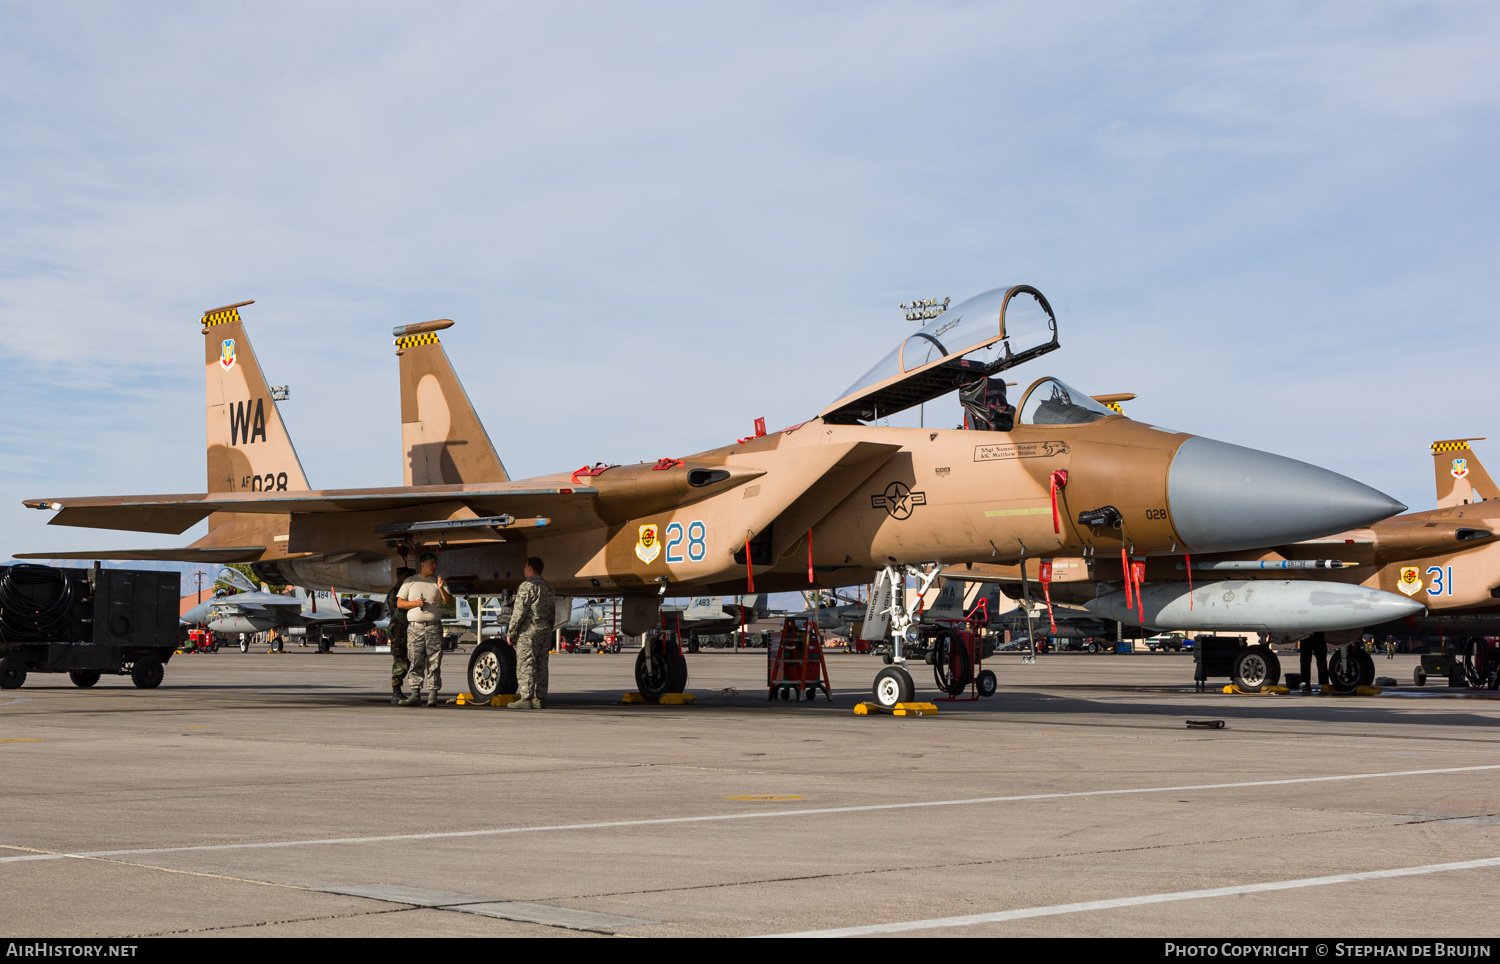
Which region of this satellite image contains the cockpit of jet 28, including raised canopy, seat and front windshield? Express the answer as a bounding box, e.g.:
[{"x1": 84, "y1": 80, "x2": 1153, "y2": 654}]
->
[{"x1": 819, "y1": 278, "x2": 1115, "y2": 432}]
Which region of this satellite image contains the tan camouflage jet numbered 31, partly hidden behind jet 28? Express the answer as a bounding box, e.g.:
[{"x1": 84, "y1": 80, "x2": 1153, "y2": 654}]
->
[{"x1": 951, "y1": 439, "x2": 1500, "y2": 688}]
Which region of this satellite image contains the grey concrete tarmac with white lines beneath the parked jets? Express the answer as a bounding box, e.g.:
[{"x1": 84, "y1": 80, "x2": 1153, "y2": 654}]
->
[{"x1": 0, "y1": 648, "x2": 1500, "y2": 939}]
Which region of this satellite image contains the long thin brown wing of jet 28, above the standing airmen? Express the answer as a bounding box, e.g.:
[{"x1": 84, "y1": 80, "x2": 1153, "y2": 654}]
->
[{"x1": 23, "y1": 483, "x2": 599, "y2": 536}]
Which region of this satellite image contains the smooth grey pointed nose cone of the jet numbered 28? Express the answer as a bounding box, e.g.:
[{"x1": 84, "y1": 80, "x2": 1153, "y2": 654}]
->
[{"x1": 1167, "y1": 436, "x2": 1406, "y2": 552}]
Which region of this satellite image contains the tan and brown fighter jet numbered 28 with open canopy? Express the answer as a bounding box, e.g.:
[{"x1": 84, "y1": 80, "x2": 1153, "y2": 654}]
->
[{"x1": 26, "y1": 285, "x2": 1404, "y2": 702}]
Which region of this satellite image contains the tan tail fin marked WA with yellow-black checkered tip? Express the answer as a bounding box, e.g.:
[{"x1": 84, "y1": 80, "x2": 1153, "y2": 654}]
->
[{"x1": 203, "y1": 301, "x2": 308, "y2": 492}]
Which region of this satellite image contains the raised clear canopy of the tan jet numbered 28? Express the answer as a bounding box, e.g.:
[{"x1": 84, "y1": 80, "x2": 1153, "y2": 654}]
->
[{"x1": 819, "y1": 285, "x2": 1058, "y2": 424}]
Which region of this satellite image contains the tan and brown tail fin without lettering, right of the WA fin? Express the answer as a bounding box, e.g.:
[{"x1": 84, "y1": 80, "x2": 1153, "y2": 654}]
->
[{"x1": 392, "y1": 319, "x2": 510, "y2": 486}]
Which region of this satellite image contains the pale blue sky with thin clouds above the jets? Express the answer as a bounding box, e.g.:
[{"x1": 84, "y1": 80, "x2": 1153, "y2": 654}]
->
[{"x1": 0, "y1": 0, "x2": 1500, "y2": 581}]
